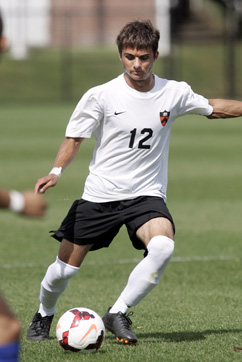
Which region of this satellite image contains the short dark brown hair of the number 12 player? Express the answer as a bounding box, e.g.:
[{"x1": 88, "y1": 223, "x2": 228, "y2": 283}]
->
[{"x1": 116, "y1": 20, "x2": 160, "y2": 56}]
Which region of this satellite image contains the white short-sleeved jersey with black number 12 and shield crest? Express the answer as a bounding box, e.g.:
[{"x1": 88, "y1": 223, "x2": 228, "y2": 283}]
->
[{"x1": 66, "y1": 74, "x2": 213, "y2": 202}]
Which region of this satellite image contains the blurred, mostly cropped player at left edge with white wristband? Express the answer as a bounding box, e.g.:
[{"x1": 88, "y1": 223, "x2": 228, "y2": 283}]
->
[{"x1": 0, "y1": 10, "x2": 47, "y2": 362}]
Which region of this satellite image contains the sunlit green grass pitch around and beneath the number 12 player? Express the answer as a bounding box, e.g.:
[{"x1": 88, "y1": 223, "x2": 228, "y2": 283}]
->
[{"x1": 0, "y1": 104, "x2": 242, "y2": 362}]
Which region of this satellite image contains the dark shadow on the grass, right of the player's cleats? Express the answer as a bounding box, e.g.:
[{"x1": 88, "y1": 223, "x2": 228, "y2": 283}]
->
[{"x1": 137, "y1": 329, "x2": 242, "y2": 343}]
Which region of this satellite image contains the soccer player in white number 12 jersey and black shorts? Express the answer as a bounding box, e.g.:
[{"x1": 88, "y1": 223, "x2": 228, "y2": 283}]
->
[{"x1": 27, "y1": 20, "x2": 242, "y2": 343}]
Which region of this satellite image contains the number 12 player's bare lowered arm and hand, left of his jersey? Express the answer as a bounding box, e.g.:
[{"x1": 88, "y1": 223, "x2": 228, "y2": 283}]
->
[{"x1": 35, "y1": 137, "x2": 84, "y2": 194}]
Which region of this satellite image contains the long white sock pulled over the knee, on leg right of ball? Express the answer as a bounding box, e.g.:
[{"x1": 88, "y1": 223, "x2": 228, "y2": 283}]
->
[{"x1": 110, "y1": 235, "x2": 174, "y2": 313}]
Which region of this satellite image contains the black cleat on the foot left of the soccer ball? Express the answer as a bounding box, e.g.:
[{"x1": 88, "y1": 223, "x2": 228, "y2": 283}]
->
[{"x1": 27, "y1": 312, "x2": 54, "y2": 341}]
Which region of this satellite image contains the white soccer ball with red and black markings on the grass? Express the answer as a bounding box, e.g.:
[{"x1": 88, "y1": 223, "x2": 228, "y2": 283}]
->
[{"x1": 56, "y1": 308, "x2": 105, "y2": 352}]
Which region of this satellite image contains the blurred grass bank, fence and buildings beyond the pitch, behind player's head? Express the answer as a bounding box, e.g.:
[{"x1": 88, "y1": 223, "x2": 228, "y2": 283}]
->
[{"x1": 0, "y1": 0, "x2": 242, "y2": 102}]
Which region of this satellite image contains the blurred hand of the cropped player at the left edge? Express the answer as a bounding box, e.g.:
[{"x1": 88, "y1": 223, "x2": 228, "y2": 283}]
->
[{"x1": 21, "y1": 191, "x2": 47, "y2": 217}]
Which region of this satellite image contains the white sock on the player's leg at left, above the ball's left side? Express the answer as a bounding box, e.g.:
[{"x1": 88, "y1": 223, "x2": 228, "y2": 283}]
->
[{"x1": 39, "y1": 257, "x2": 80, "y2": 317}]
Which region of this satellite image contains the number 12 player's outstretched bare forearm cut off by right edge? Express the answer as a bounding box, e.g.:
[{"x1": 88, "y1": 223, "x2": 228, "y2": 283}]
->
[{"x1": 207, "y1": 98, "x2": 242, "y2": 118}]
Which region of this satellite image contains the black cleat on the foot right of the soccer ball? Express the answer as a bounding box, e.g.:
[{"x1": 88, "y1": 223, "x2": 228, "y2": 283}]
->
[{"x1": 103, "y1": 308, "x2": 138, "y2": 344}]
